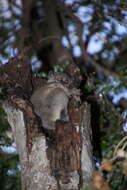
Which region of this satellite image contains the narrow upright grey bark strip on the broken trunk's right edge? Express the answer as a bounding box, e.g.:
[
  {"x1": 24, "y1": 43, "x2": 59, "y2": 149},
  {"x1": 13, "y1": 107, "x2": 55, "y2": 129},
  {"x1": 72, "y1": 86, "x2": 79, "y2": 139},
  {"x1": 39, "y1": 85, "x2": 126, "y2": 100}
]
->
[{"x1": 80, "y1": 102, "x2": 93, "y2": 187}]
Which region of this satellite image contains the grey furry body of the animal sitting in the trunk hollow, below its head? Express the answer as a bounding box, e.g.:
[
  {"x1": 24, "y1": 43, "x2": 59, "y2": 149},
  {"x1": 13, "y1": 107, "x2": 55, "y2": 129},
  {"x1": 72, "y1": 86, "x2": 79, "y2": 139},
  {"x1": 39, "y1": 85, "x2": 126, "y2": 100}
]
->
[{"x1": 31, "y1": 85, "x2": 69, "y2": 129}]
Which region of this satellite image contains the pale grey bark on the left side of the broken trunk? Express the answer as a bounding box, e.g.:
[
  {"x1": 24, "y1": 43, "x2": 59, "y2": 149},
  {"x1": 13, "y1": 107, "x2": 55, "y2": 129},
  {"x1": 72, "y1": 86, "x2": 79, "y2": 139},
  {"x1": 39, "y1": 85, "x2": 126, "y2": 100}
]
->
[{"x1": 3, "y1": 99, "x2": 58, "y2": 190}]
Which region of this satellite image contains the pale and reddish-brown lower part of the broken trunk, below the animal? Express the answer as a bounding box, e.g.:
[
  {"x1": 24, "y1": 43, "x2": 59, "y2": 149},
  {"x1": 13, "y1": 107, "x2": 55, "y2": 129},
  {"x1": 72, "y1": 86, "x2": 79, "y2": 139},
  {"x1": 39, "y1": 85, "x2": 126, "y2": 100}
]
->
[{"x1": 3, "y1": 94, "x2": 92, "y2": 190}]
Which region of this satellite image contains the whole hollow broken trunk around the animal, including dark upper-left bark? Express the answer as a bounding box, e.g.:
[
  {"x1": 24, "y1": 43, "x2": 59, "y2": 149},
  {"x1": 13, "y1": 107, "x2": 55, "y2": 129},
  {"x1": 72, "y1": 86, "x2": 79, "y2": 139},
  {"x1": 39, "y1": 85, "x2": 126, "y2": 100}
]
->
[{"x1": 0, "y1": 56, "x2": 92, "y2": 190}]
